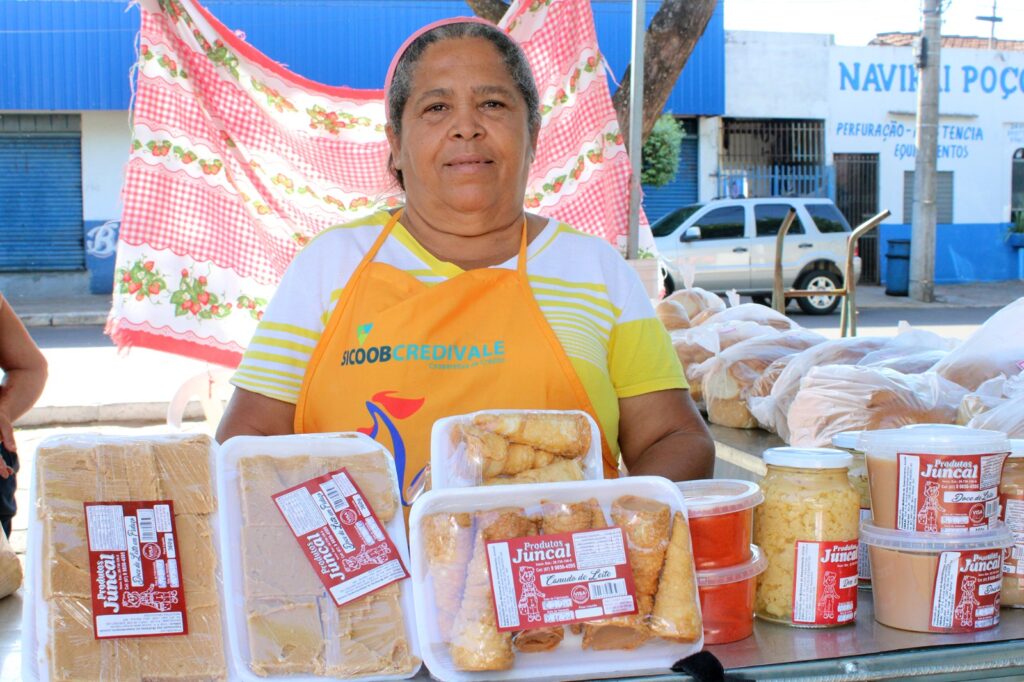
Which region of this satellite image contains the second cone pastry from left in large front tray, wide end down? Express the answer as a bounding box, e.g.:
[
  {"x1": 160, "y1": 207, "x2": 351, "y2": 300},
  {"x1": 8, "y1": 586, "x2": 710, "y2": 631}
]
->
[{"x1": 451, "y1": 508, "x2": 535, "y2": 671}]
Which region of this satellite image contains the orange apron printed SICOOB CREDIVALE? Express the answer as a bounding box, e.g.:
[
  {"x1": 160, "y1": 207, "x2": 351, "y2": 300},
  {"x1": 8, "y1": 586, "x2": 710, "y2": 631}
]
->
[{"x1": 295, "y1": 212, "x2": 617, "y2": 506}]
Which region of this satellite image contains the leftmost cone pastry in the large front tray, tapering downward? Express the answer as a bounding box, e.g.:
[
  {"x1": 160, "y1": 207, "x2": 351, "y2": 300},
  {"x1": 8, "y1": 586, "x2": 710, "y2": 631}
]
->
[{"x1": 423, "y1": 512, "x2": 473, "y2": 642}]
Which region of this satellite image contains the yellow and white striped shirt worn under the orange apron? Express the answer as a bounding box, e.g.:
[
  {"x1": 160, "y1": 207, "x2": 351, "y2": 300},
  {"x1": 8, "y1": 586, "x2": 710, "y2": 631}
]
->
[{"x1": 231, "y1": 212, "x2": 686, "y2": 453}]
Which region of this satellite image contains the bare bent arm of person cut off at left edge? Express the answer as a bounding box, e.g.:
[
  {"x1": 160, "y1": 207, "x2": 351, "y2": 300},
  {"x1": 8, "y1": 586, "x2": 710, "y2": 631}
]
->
[{"x1": 0, "y1": 298, "x2": 47, "y2": 453}]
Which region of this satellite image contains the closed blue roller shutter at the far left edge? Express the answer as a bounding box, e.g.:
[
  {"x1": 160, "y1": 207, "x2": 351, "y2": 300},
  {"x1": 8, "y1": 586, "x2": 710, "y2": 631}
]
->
[{"x1": 0, "y1": 134, "x2": 85, "y2": 272}]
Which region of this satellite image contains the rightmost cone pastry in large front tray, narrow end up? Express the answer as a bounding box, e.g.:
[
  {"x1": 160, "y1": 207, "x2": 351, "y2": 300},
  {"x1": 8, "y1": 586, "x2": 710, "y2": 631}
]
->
[{"x1": 650, "y1": 512, "x2": 701, "y2": 642}]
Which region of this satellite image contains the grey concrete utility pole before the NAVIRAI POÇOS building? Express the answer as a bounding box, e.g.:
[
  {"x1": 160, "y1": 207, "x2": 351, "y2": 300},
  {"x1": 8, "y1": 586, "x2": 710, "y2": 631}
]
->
[{"x1": 909, "y1": 0, "x2": 942, "y2": 303}]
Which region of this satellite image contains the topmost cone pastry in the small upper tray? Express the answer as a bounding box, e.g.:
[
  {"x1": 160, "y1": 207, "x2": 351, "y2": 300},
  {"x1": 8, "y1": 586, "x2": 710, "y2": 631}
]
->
[{"x1": 473, "y1": 412, "x2": 590, "y2": 457}]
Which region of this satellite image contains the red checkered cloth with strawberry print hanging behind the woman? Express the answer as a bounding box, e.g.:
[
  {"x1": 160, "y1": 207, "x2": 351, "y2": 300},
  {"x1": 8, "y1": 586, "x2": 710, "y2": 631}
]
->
[{"x1": 108, "y1": 0, "x2": 649, "y2": 367}]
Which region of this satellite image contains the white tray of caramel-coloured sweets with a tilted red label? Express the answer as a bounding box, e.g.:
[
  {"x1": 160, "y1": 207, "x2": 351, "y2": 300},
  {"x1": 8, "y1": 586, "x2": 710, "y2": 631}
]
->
[{"x1": 218, "y1": 433, "x2": 421, "y2": 681}]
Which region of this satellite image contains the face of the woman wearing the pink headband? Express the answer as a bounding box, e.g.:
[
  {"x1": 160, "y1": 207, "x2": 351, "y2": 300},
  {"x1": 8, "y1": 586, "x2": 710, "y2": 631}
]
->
[{"x1": 387, "y1": 38, "x2": 536, "y2": 223}]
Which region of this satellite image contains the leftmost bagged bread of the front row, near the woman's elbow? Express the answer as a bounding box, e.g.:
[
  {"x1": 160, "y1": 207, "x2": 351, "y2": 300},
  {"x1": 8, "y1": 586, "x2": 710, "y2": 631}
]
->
[{"x1": 699, "y1": 329, "x2": 825, "y2": 429}]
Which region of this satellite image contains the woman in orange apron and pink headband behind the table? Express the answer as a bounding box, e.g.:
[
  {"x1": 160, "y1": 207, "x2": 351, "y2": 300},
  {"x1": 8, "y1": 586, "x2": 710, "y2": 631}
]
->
[{"x1": 217, "y1": 18, "x2": 714, "y2": 504}]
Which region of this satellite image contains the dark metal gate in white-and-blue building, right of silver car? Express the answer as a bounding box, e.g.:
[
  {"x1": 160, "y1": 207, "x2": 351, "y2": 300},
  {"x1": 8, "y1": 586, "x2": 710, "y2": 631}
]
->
[{"x1": 833, "y1": 154, "x2": 881, "y2": 284}]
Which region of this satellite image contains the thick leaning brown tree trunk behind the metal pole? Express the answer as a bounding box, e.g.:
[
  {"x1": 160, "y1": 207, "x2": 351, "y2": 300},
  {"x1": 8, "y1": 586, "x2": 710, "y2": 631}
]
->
[{"x1": 611, "y1": 0, "x2": 718, "y2": 148}]
